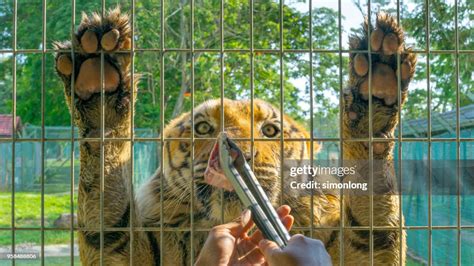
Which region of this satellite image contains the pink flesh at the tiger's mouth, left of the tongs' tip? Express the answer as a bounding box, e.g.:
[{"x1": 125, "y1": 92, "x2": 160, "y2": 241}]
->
[{"x1": 204, "y1": 142, "x2": 234, "y2": 191}]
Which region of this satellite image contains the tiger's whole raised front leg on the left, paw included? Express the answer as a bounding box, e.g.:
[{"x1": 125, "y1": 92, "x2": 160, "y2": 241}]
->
[{"x1": 55, "y1": 9, "x2": 156, "y2": 265}]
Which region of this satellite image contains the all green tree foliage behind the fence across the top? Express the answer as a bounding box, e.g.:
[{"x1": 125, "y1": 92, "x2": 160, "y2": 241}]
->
[{"x1": 0, "y1": 0, "x2": 474, "y2": 133}]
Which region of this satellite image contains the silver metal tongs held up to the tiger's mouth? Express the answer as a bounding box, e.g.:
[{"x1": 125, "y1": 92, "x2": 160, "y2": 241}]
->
[{"x1": 217, "y1": 132, "x2": 290, "y2": 248}]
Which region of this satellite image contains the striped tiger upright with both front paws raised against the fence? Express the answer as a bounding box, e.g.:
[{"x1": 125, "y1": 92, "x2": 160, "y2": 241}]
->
[{"x1": 54, "y1": 8, "x2": 416, "y2": 265}]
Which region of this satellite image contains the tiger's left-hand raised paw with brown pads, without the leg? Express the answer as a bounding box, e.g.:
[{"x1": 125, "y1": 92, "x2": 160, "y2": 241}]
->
[{"x1": 55, "y1": 8, "x2": 131, "y2": 101}]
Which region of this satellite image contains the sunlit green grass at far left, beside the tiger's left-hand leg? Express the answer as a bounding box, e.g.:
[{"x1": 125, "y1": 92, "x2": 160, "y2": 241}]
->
[{"x1": 0, "y1": 192, "x2": 77, "y2": 245}]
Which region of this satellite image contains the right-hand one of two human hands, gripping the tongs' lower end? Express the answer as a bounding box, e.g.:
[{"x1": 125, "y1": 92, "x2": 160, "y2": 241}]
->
[{"x1": 258, "y1": 234, "x2": 332, "y2": 266}]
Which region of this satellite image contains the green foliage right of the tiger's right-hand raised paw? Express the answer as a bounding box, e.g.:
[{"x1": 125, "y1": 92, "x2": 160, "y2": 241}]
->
[{"x1": 402, "y1": 1, "x2": 474, "y2": 119}]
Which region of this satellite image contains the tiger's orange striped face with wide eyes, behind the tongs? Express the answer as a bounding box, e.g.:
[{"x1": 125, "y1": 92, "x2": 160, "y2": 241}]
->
[{"x1": 163, "y1": 99, "x2": 310, "y2": 221}]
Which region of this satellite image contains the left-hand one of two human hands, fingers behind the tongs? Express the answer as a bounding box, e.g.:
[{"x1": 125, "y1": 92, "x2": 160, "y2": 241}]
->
[{"x1": 195, "y1": 205, "x2": 294, "y2": 266}]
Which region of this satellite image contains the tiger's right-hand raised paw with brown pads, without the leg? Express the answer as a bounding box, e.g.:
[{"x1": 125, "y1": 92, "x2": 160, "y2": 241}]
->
[{"x1": 350, "y1": 13, "x2": 416, "y2": 106}]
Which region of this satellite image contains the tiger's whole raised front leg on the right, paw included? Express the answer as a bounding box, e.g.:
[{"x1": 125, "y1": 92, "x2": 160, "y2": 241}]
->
[{"x1": 343, "y1": 13, "x2": 416, "y2": 264}]
